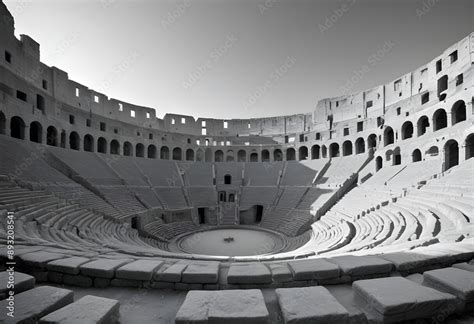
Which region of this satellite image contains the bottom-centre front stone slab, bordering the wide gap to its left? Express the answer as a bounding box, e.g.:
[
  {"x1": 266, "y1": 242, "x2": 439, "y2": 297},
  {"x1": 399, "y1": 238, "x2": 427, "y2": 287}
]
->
[{"x1": 175, "y1": 289, "x2": 269, "y2": 324}]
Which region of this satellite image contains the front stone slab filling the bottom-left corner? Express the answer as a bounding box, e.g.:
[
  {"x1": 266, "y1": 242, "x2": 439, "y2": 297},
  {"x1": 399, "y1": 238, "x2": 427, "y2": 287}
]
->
[{"x1": 0, "y1": 286, "x2": 74, "y2": 323}]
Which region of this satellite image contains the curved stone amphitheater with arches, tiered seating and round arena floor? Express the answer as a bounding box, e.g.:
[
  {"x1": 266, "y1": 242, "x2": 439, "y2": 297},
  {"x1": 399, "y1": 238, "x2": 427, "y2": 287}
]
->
[{"x1": 0, "y1": 2, "x2": 474, "y2": 323}]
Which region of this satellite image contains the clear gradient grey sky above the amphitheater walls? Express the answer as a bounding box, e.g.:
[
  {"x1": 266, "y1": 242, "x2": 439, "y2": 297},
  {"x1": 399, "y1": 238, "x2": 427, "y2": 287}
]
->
[{"x1": 4, "y1": 0, "x2": 473, "y2": 118}]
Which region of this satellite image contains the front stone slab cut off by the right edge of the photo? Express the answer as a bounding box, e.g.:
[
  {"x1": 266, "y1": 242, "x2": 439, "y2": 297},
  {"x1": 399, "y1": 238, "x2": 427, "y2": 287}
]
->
[{"x1": 423, "y1": 268, "x2": 474, "y2": 303}]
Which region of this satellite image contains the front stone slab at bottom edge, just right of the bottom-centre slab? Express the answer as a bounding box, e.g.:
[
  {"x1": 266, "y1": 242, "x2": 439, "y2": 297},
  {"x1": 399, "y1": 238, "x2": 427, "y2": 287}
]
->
[{"x1": 276, "y1": 287, "x2": 349, "y2": 324}]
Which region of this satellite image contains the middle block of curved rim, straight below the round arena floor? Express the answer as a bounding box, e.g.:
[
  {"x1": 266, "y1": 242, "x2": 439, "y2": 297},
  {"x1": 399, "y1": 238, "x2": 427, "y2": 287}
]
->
[{"x1": 227, "y1": 262, "x2": 272, "y2": 284}]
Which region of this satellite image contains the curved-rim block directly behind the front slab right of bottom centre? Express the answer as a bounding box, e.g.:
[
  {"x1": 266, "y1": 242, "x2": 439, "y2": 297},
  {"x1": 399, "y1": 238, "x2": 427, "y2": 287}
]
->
[{"x1": 288, "y1": 259, "x2": 341, "y2": 280}]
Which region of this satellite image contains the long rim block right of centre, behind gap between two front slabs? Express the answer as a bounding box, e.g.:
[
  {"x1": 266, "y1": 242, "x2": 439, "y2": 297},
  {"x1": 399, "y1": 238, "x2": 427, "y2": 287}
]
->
[{"x1": 328, "y1": 255, "x2": 393, "y2": 277}]
